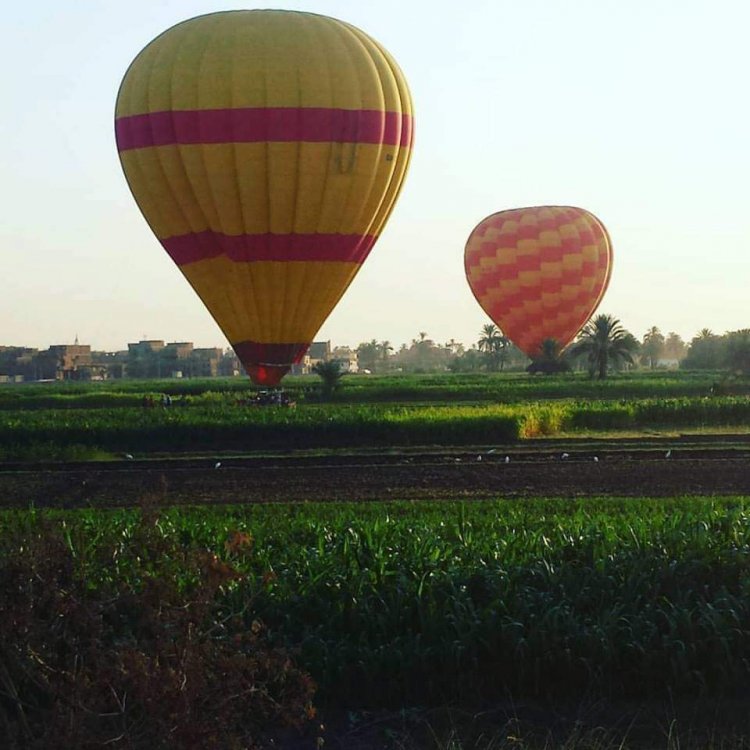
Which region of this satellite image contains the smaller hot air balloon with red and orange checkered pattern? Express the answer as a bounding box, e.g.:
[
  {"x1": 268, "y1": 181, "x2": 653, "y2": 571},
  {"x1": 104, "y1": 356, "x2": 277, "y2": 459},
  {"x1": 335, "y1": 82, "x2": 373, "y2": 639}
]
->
[{"x1": 464, "y1": 206, "x2": 612, "y2": 357}]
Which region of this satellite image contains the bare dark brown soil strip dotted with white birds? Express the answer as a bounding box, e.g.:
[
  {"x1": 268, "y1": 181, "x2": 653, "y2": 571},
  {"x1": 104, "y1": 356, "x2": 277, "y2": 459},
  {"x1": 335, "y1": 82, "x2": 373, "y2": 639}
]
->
[{"x1": 0, "y1": 447, "x2": 750, "y2": 507}]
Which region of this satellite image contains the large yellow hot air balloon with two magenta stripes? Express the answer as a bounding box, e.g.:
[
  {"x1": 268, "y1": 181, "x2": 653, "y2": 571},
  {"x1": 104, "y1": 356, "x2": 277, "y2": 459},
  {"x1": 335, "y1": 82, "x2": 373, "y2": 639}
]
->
[{"x1": 115, "y1": 10, "x2": 413, "y2": 385}]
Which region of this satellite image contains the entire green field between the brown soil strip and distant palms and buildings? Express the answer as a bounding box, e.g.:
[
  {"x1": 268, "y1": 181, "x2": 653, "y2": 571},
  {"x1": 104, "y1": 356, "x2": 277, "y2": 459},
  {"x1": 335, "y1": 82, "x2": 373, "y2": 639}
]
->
[{"x1": 0, "y1": 373, "x2": 750, "y2": 460}]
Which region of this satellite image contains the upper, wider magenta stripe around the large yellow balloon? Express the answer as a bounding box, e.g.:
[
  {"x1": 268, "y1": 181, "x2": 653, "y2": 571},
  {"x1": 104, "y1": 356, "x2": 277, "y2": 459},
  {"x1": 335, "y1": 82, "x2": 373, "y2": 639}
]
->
[{"x1": 115, "y1": 107, "x2": 413, "y2": 151}]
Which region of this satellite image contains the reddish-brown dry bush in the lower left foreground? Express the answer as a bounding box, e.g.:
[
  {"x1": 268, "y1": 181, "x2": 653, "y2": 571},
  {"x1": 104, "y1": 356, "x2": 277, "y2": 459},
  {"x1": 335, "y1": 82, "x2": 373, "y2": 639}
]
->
[{"x1": 0, "y1": 513, "x2": 314, "y2": 750}]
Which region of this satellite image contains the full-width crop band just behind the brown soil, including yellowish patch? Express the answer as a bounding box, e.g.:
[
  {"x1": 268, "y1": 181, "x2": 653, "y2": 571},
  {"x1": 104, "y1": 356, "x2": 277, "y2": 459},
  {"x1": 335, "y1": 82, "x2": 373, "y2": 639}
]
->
[{"x1": 0, "y1": 397, "x2": 750, "y2": 459}]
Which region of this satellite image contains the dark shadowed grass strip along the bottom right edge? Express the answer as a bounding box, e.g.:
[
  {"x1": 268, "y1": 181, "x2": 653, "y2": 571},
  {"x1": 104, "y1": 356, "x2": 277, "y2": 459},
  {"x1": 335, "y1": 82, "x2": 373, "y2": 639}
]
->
[{"x1": 325, "y1": 699, "x2": 750, "y2": 750}]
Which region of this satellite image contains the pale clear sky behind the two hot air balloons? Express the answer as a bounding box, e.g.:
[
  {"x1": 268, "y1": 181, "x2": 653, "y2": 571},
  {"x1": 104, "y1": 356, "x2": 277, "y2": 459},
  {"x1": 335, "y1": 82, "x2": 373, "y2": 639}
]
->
[{"x1": 0, "y1": 0, "x2": 750, "y2": 350}]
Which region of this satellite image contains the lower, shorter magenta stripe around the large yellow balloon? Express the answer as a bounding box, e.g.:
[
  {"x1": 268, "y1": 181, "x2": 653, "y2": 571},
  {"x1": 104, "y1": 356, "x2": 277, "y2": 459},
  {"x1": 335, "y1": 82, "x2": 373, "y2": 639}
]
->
[{"x1": 161, "y1": 230, "x2": 377, "y2": 266}]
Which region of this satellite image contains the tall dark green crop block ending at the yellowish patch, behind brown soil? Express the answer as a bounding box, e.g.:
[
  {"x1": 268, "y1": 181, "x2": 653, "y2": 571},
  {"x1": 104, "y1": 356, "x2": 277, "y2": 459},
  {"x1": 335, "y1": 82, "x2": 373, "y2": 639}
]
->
[{"x1": 0, "y1": 406, "x2": 523, "y2": 457}]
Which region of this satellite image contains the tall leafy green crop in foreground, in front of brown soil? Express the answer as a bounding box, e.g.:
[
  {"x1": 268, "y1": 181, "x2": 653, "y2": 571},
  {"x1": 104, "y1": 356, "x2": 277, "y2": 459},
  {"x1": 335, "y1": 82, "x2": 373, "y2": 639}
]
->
[{"x1": 5, "y1": 498, "x2": 750, "y2": 706}]
